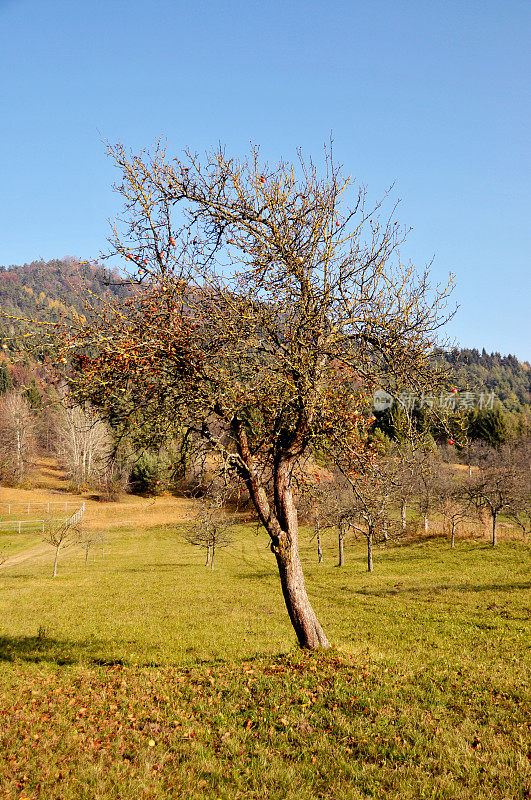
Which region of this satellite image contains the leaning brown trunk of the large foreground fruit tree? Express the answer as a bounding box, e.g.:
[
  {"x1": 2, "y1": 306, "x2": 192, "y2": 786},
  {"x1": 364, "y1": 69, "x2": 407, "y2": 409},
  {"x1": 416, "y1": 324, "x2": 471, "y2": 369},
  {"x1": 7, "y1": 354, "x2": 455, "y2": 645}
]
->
[{"x1": 271, "y1": 462, "x2": 330, "y2": 650}]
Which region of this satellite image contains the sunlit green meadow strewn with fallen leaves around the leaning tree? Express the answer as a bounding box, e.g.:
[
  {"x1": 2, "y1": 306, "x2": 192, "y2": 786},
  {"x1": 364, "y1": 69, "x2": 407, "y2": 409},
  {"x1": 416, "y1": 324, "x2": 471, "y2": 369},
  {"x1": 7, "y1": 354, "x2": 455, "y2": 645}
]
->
[{"x1": 0, "y1": 527, "x2": 531, "y2": 800}]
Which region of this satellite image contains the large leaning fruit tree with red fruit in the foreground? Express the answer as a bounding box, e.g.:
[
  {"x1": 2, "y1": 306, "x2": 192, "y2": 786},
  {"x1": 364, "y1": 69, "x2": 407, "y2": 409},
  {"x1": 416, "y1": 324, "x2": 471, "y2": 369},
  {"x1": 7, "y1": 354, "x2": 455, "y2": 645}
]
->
[{"x1": 41, "y1": 145, "x2": 454, "y2": 649}]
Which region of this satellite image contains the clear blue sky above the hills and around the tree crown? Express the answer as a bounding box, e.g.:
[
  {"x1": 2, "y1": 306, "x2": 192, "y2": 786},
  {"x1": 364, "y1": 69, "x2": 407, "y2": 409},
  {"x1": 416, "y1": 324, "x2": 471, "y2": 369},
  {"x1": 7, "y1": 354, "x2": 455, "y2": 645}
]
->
[{"x1": 0, "y1": 0, "x2": 531, "y2": 360}]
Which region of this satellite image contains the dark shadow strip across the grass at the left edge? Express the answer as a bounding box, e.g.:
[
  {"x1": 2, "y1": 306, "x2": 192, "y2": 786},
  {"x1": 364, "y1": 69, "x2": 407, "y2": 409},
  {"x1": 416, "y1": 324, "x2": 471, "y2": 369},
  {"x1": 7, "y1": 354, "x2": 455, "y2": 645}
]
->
[{"x1": 0, "y1": 633, "x2": 127, "y2": 666}]
